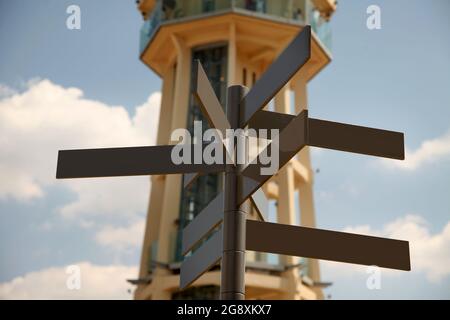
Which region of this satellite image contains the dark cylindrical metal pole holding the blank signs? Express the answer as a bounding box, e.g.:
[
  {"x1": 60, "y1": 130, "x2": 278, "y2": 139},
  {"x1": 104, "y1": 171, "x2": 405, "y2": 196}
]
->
[{"x1": 220, "y1": 86, "x2": 247, "y2": 300}]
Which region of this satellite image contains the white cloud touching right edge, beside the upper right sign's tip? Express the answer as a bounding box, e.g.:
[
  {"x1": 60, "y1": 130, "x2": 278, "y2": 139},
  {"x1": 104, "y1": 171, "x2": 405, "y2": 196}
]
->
[{"x1": 380, "y1": 131, "x2": 450, "y2": 171}]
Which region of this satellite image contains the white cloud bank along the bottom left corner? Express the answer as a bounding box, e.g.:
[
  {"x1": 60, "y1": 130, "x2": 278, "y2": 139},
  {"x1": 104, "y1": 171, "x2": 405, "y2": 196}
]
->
[{"x1": 0, "y1": 262, "x2": 137, "y2": 300}]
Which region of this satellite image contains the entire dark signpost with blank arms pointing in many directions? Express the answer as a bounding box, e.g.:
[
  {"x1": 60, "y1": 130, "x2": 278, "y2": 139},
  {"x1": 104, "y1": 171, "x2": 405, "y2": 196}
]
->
[{"x1": 56, "y1": 27, "x2": 410, "y2": 299}]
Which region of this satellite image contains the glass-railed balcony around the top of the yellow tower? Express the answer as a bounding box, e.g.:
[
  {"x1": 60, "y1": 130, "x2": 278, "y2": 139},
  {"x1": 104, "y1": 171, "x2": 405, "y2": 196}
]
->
[{"x1": 138, "y1": 0, "x2": 335, "y2": 74}]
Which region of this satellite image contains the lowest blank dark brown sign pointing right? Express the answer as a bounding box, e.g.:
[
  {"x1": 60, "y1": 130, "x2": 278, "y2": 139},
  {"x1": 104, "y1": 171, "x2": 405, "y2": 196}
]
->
[{"x1": 246, "y1": 220, "x2": 411, "y2": 271}]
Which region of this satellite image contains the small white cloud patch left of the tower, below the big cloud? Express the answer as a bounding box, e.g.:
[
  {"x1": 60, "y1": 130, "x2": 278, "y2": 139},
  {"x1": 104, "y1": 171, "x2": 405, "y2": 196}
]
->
[{"x1": 96, "y1": 219, "x2": 145, "y2": 251}]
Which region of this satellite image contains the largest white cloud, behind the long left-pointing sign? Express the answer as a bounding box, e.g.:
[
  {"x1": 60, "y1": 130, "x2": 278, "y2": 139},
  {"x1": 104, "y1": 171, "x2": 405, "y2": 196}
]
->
[{"x1": 0, "y1": 80, "x2": 161, "y2": 221}]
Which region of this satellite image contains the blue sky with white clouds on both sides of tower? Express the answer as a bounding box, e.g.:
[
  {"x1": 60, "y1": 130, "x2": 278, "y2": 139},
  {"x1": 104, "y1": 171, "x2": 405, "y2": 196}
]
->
[{"x1": 0, "y1": 0, "x2": 450, "y2": 299}]
